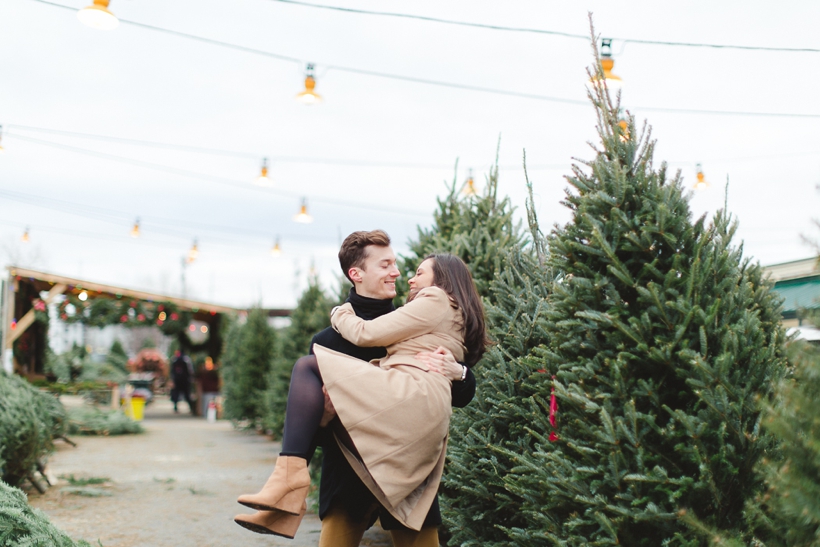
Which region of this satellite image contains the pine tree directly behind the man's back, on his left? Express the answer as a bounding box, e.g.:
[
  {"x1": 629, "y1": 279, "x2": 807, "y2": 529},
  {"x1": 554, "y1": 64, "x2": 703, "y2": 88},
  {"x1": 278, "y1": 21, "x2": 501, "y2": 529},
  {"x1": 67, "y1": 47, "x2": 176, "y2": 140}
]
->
[{"x1": 262, "y1": 276, "x2": 336, "y2": 437}]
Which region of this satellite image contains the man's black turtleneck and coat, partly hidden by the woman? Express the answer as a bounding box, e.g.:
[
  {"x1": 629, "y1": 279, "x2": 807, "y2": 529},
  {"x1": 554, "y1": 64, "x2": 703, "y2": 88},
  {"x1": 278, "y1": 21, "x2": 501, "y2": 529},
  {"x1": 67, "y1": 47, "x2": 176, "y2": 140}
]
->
[{"x1": 310, "y1": 288, "x2": 476, "y2": 530}]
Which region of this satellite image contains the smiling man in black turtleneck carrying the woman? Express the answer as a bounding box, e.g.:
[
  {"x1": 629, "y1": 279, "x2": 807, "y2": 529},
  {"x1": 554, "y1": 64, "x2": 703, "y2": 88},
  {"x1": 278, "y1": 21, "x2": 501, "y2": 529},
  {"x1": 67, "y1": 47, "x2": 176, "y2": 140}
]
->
[{"x1": 311, "y1": 230, "x2": 475, "y2": 547}]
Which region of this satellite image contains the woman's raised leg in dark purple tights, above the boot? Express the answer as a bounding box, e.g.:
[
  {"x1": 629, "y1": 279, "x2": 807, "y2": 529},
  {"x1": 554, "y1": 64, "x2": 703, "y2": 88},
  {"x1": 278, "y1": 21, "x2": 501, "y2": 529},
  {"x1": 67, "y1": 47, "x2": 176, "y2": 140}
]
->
[{"x1": 281, "y1": 355, "x2": 325, "y2": 460}]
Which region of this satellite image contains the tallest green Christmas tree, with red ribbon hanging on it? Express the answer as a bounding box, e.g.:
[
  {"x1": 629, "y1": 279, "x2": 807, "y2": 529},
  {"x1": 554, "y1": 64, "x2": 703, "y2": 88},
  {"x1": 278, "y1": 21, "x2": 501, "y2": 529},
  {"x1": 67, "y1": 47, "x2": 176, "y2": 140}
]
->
[{"x1": 448, "y1": 37, "x2": 785, "y2": 547}]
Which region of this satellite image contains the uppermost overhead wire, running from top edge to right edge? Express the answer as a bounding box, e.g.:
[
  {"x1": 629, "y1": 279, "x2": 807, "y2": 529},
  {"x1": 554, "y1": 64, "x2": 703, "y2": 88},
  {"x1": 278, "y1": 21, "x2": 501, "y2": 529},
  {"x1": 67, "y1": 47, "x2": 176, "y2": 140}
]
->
[{"x1": 271, "y1": 0, "x2": 820, "y2": 53}]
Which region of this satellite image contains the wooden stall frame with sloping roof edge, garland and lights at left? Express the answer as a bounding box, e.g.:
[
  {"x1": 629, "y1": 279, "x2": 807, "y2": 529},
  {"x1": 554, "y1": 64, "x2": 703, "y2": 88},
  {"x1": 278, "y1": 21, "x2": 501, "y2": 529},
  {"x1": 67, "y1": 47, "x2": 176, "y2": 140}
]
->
[{"x1": 0, "y1": 266, "x2": 291, "y2": 376}]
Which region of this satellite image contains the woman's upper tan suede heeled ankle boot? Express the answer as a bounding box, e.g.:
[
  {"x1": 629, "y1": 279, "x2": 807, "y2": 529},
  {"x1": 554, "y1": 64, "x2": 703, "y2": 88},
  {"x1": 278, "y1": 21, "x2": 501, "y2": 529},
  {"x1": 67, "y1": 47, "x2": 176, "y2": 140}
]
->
[{"x1": 236, "y1": 456, "x2": 310, "y2": 515}]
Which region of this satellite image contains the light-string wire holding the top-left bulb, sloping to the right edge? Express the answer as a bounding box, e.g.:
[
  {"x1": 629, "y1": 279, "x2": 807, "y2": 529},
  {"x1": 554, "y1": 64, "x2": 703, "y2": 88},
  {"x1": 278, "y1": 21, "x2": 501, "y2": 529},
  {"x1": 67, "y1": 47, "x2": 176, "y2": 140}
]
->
[{"x1": 25, "y1": 0, "x2": 820, "y2": 119}]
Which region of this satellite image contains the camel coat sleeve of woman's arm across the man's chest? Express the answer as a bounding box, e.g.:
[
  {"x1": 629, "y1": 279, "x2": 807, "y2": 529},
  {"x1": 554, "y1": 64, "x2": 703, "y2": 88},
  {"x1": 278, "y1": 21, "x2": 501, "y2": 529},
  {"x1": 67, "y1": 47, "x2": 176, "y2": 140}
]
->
[{"x1": 330, "y1": 287, "x2": 451, "y2": 347}]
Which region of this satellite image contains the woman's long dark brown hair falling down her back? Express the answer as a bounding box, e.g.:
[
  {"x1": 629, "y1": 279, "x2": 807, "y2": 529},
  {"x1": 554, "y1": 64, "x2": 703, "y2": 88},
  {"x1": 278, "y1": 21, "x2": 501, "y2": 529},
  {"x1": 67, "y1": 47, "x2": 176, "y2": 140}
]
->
[{"x1": 424, "y1": 253, "x2": 490, "y2": 367}]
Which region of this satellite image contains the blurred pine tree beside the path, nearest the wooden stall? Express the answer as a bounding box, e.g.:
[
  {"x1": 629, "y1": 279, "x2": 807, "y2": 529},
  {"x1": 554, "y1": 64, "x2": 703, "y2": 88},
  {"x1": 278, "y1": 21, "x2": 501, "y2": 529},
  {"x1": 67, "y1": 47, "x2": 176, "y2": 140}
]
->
[{"x1": 222, "y1": 308, "x2": 276, "y2": 425}]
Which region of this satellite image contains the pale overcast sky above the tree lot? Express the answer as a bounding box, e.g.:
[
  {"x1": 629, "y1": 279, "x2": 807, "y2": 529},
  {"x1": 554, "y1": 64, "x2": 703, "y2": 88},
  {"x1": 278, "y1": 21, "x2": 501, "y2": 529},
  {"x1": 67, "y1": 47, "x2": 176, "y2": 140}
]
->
[{"x1": 0, "y1": 0, "x2": 820, "y2": 307}]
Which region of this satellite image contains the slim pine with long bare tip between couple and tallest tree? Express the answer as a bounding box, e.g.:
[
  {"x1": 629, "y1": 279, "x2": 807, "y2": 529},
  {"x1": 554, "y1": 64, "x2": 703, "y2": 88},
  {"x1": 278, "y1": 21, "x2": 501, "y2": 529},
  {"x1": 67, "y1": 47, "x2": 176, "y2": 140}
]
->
[{"x1": 441, "y1": 182, "x2": 552, "y2": 546}]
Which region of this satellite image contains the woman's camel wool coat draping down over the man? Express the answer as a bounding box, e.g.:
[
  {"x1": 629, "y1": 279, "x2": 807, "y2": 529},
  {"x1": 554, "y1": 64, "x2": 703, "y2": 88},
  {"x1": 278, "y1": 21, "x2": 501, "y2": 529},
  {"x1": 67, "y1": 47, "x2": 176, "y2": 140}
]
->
[{"x1": 314, "y1": 287, "x2": 465, "y2": 530}]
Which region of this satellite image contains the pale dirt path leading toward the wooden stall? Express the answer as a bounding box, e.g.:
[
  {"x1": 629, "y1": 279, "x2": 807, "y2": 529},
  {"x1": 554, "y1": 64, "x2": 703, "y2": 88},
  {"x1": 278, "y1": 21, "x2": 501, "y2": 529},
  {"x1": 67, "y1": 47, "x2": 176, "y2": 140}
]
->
[{"x1": 29, "y1": 400, "x2": 392, "y2": 547}]
